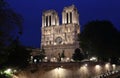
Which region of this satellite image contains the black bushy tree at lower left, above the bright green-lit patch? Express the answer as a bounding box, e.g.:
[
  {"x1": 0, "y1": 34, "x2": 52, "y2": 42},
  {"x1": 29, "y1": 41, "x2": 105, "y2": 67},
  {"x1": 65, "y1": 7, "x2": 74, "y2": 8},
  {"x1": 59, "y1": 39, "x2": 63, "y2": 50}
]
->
[{"x1": 5, "y1": 39, "x2": 31, "y2": 68}]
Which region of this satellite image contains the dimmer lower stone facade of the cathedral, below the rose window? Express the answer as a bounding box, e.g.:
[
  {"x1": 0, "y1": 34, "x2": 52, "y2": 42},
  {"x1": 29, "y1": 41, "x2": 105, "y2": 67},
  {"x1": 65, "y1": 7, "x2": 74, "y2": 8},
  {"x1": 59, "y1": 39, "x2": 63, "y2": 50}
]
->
[{"x1": 44, "y1": 44, "x2": 78, "y2": 58}]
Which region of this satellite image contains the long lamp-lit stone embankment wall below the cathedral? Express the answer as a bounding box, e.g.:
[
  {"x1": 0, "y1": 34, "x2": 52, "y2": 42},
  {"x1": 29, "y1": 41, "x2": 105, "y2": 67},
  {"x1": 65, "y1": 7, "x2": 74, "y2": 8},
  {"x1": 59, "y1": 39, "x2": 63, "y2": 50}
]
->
[{"x1": 13, "y1": 62, "x2": 113, "y2": 78}]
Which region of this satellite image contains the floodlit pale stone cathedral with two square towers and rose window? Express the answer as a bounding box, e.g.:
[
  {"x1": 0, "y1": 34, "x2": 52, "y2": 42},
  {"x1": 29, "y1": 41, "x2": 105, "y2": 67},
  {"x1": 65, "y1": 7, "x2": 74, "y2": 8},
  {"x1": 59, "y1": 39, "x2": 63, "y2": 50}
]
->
[{"x1": 41, "y1": 5, "x2": 80, "y2": 60}]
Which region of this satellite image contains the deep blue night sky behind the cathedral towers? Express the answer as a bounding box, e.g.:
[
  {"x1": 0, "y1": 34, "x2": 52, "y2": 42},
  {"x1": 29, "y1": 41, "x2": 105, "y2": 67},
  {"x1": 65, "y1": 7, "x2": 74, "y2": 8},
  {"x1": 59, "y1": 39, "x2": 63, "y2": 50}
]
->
[{"x1": 6, "y1": 0, "x2": 120, "y2": 48}]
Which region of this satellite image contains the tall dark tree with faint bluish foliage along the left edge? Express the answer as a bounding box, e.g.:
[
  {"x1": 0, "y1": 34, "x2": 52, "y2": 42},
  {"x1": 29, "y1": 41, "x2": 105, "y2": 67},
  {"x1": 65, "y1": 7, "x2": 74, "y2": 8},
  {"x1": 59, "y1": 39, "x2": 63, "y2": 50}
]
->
[{"x1": 0, "y1": 0, "x2": 22, "y2": 64}]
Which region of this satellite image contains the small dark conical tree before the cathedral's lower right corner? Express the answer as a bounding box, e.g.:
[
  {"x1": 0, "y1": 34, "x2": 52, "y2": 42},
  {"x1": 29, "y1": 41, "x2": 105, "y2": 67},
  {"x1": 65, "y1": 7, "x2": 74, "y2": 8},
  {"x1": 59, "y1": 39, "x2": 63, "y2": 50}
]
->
[{"x1": 72, "y1": 48, "x2": 84, "y2": 61}]
